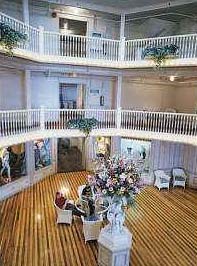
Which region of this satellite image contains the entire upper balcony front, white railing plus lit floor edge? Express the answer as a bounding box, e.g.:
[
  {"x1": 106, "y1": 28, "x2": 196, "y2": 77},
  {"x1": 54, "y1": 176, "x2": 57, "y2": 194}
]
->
[{"x1": 0, "y1": 12, "x2": 197, "y2": 69}]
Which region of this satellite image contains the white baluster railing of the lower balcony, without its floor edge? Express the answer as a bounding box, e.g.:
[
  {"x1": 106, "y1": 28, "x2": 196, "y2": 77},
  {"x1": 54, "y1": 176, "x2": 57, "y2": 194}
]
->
[{"x1": 0, "y1": 109, "x2": 197, "y2": 138}]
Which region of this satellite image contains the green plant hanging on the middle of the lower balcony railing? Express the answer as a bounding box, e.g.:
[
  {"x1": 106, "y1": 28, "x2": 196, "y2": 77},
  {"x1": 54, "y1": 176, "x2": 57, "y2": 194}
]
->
[{"x1": 68, "y1": 118, "x2": 98, "y2": 137}]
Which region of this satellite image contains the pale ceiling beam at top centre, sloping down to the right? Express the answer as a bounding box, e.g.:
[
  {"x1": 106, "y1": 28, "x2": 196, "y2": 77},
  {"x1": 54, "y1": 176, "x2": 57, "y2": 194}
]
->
[{"x1": 39, "y1": 0, "x2": 121, "y2": 15}]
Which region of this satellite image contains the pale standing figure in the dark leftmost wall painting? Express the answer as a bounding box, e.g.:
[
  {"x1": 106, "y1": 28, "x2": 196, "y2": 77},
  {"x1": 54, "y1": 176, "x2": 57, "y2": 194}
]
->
[{"x1": 0, "y1": 148, "x2": 11, "y2": 183}]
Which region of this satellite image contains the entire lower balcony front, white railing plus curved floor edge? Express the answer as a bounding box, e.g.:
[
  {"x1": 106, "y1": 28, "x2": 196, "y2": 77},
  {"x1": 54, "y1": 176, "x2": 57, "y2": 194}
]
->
[{"x1": 0, "y1": 109, "x2": 197, "y2": 147}]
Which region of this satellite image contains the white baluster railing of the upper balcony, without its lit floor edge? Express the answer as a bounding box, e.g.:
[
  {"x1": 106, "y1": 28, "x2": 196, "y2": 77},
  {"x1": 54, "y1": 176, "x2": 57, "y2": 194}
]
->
[{"x1": 0, "y1": 12, "x2": 197, "y2": 66}]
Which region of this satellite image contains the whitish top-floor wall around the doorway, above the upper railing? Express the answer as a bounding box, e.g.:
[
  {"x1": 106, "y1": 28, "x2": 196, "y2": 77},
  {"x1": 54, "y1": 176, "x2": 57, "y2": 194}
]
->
[{"x1": 0, "y1": 0, "x2": 120, "y2": 38}]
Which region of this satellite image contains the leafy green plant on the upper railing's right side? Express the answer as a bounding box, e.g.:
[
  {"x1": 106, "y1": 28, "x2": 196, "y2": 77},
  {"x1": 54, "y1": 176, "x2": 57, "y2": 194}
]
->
[{"x1": 142, "y1": 44, "x2": 179, "y2": 68}]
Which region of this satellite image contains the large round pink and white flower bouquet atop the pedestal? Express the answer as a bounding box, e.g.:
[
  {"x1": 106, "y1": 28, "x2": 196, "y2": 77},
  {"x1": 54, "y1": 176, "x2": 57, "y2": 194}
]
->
[{"x1": 94, "y1": 156, "x2": 140, "y2": 205}]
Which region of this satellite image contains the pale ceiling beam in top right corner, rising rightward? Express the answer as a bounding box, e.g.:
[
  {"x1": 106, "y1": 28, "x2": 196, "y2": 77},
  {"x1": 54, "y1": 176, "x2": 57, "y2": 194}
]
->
[{"x1": 124, "y1": 0, "x2": 197, "y2": 15}]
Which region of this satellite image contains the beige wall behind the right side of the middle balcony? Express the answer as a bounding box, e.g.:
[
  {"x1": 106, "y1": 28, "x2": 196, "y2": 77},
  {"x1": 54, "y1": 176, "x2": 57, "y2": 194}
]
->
[{"x1": 121, "y1": 78, "x2": 197, "y2": 113}]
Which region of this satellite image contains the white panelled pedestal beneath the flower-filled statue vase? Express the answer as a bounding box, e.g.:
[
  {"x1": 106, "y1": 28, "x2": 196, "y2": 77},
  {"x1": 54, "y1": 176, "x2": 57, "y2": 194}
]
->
[{"x1": 98, "y1": 226, "x2": 132, "y2": 266}]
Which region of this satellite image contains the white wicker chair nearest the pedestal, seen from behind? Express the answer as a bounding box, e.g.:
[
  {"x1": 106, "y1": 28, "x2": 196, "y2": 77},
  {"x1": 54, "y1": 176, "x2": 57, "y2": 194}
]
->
[{"x1": 81, "y1": 216, "x2": 103, "y2": 243}]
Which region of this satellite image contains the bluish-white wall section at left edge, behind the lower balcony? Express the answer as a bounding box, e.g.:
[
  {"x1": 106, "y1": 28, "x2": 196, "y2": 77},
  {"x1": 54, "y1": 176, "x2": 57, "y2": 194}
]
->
[{"x1": 0, "y1": 70, "x2": 25, "y2": 110}]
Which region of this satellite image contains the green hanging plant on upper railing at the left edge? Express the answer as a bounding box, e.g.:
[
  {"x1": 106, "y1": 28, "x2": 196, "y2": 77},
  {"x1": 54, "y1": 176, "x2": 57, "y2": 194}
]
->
[{"x1": 0, "y1": 22, "x2": 27, "y2": 56}]
